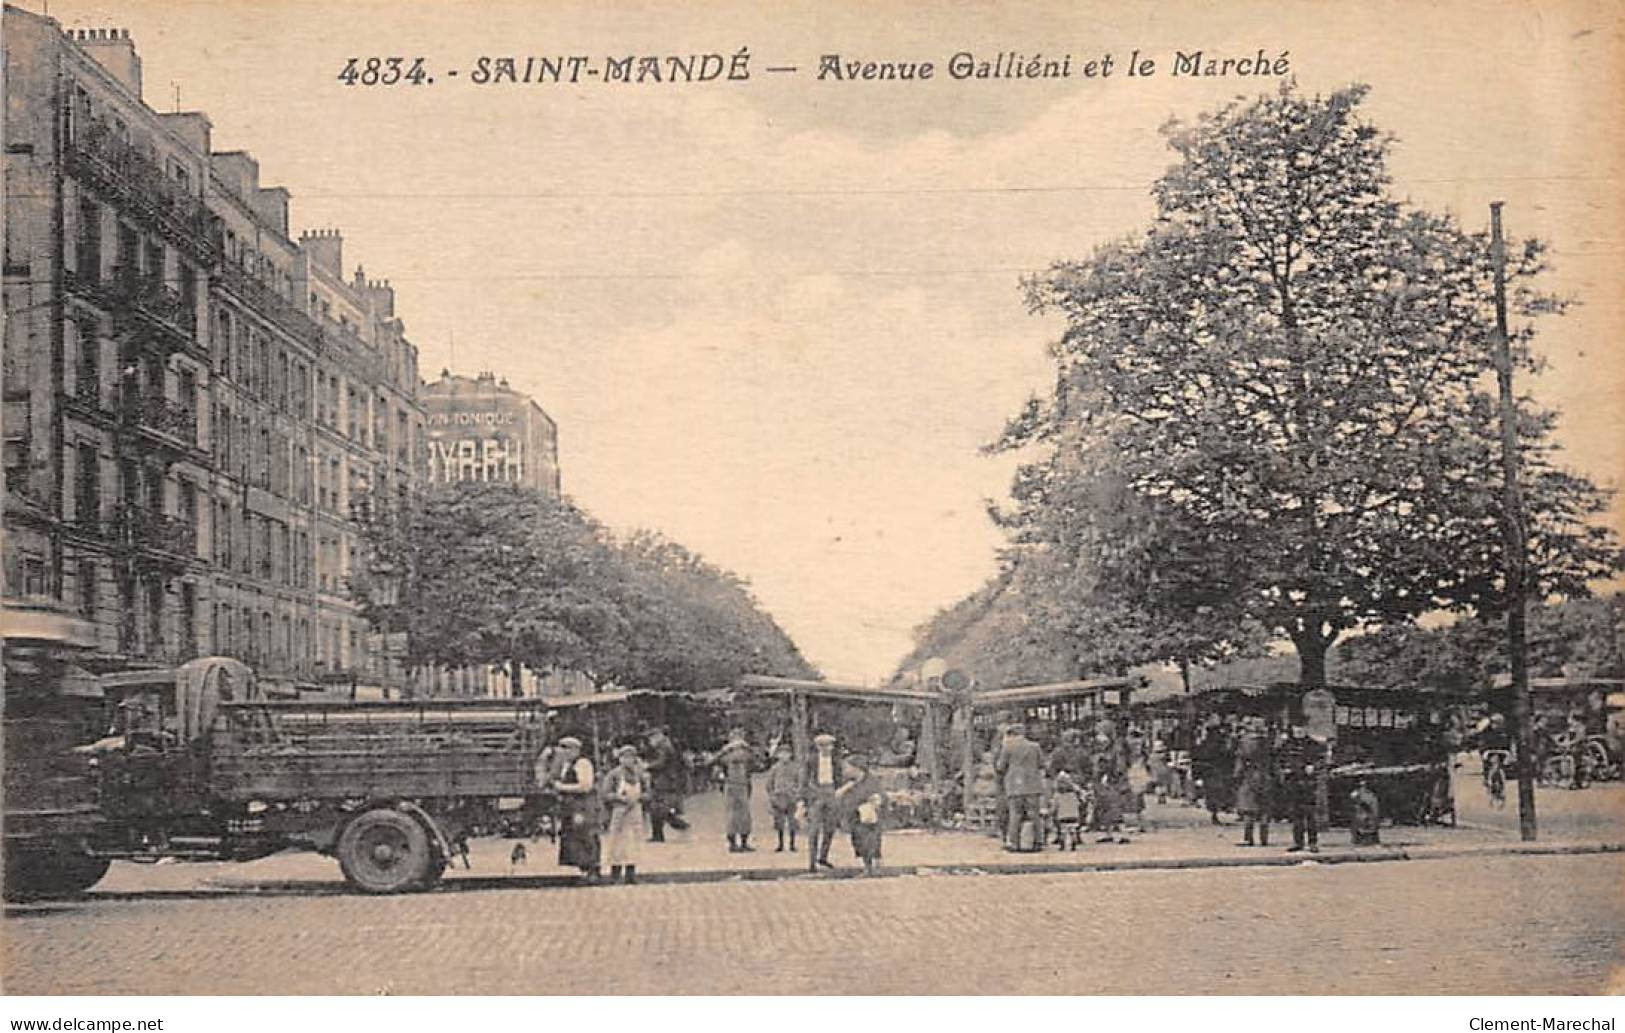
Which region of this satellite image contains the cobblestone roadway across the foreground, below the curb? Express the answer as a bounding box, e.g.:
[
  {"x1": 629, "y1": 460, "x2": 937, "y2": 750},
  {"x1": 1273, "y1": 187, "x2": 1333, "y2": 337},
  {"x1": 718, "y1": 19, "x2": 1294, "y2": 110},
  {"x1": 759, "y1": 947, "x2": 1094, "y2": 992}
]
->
[{"x1": 3, "y1": 854, "x2": 1625, "y2": 994}]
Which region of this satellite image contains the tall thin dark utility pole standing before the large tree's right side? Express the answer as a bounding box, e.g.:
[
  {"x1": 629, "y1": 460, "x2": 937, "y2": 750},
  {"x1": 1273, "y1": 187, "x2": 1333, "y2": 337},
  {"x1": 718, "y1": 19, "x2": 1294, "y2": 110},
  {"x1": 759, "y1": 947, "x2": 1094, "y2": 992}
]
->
[{"x1": 1490, "y1": 201, "x2": 1536, "y2": 841}]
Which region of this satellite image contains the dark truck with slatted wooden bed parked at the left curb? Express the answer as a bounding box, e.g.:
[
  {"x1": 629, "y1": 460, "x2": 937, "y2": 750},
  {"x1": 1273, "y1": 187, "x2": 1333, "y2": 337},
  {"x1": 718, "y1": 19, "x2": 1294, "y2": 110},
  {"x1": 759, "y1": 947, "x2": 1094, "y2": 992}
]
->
[{"x1": 5, "y1": 642, "x2": 548, "y2": 898}]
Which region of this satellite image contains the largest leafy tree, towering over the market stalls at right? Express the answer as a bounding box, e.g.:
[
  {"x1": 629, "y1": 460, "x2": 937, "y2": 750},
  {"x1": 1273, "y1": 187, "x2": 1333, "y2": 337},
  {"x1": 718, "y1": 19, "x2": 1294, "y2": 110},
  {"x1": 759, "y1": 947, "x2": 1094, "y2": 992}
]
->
[{"x1": 1001, "y1": 86, "x2": 1620, "y2": 684}]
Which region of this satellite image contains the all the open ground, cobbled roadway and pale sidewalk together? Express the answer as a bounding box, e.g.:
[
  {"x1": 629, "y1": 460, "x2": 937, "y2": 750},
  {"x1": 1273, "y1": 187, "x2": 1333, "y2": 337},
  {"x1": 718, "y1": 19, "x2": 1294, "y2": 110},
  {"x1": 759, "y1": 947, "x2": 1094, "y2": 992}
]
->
[{"x1": 0, "y1": 767, "x2": 1625, "y2": 994}]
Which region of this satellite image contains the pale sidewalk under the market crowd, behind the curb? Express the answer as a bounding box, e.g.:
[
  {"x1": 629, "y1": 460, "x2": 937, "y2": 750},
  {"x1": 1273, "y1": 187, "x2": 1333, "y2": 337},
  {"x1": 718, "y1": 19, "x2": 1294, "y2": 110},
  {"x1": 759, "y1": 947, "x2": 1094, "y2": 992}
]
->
[{"x1": 98, "y1": 773, "x2": 1625, "y2": 893}]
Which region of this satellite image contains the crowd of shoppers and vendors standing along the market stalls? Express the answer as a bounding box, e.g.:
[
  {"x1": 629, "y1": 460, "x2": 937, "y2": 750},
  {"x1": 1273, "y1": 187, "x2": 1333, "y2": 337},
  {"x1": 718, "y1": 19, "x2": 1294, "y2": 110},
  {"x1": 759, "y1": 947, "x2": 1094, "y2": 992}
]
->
[{"x1": 536, "y1": 688, "x2": 1606, "y2": 882}]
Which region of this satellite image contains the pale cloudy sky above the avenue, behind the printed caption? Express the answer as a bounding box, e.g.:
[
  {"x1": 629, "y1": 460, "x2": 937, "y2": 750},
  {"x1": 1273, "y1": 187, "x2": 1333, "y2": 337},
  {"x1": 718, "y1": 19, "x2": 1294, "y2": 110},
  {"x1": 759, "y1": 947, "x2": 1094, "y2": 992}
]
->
[{"x1": 23, "y1": 0, "x2": 1625, "y2": 681}]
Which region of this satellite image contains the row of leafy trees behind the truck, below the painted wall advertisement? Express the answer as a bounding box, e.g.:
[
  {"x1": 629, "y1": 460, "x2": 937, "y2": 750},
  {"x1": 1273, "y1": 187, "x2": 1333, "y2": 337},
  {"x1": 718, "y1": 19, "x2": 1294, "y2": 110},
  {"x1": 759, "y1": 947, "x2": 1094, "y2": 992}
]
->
[{"x1": 353, "y1": 481, "x2": 816, "y2": 690}]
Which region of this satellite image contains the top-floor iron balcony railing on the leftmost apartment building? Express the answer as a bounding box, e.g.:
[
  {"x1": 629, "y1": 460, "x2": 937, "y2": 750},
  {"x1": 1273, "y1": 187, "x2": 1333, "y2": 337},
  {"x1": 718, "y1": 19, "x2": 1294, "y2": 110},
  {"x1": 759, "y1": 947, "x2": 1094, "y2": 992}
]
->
[{"x1": 67, "y1": 122, "x2": 215, "y2": 261}]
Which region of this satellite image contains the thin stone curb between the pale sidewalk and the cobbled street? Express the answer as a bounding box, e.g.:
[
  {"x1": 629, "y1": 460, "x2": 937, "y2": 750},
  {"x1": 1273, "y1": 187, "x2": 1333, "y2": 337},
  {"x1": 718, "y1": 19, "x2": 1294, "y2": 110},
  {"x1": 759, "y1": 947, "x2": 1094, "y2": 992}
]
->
[{"x1": 88, "y1": 841, "x2": 1625, "y2": 900}]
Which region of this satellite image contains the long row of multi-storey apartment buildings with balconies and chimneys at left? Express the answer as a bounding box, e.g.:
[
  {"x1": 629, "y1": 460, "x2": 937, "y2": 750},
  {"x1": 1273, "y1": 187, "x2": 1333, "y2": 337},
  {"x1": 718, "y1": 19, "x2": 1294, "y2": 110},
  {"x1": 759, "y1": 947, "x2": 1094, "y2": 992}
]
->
[{"x1": 3, "y1": 6, "x2": 424, "y2": 694}]
